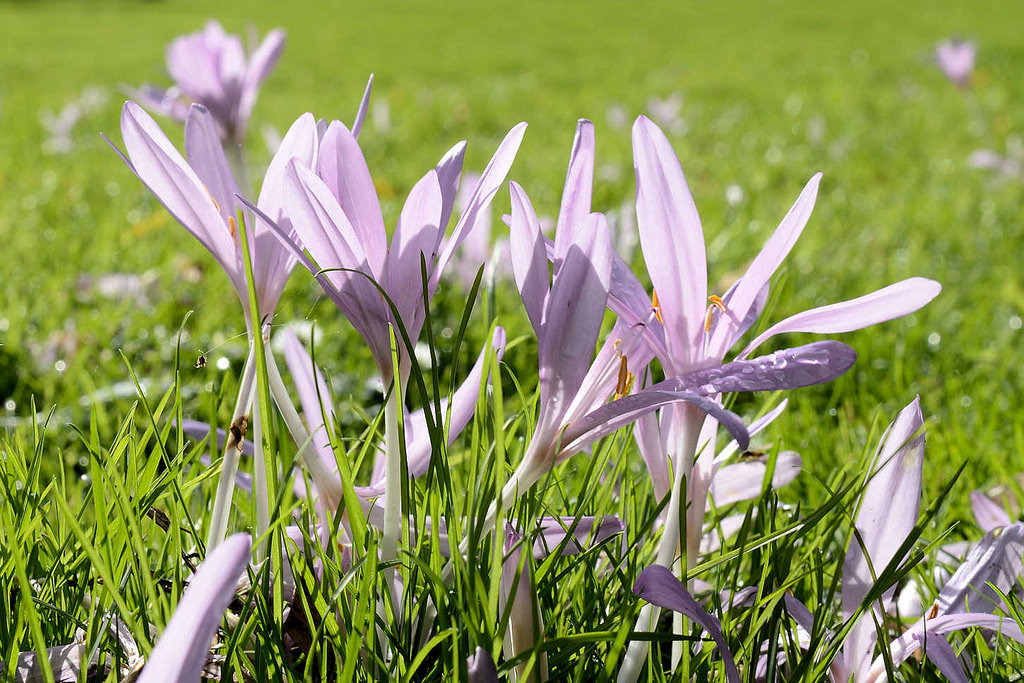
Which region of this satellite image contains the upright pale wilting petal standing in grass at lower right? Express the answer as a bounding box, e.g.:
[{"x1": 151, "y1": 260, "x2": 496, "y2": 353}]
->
[{"x1": 842, "y1": 398, "x2": 925, "y2": 674}]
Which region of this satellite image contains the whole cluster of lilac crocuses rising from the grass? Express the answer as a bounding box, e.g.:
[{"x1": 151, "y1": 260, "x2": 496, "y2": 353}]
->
[{"x1": 18, "y1": 22, "x2": 1024, "y2": 683}]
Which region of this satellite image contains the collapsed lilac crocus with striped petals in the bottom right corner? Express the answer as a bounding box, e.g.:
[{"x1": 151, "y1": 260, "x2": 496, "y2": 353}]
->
[{"x1": 785, "y1": 398, "x2": 1024, "y2": 683}]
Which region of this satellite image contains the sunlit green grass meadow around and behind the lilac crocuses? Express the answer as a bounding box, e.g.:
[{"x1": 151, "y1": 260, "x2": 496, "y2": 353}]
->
[{"x1": 0, "y1": 0, "x2": 1024, "y2": 681}]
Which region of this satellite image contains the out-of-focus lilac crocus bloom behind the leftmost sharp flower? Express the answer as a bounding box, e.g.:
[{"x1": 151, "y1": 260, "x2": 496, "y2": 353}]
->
[{"x1": 132, "y1": 20, "x2": 285, "y2": 144}]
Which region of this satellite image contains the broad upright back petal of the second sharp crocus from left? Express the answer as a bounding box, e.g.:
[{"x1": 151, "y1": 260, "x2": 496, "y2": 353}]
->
[{"x1": 307, "y1": 121, "x2": 387, "y2": 282}]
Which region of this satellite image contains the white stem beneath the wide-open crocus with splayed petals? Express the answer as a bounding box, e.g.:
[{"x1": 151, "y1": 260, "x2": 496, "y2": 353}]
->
[{"x1": 616, "y1": 403, "x2": 703, "y2": 683}]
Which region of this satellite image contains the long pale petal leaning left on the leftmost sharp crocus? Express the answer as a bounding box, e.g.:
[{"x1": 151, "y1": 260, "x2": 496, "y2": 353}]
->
[{"x1": 121, "y1": 101, "x2": 238, "y2": 290}]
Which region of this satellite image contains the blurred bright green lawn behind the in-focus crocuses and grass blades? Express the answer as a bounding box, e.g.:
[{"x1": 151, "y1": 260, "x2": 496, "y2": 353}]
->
[{"x1": 0, "y1": 0, "x2": 1024, "y2": 511}]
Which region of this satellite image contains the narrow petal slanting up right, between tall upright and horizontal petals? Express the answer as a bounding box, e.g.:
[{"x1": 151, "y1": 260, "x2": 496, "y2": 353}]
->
[{"x1": 708, "y1": 173, "x2": 821, "y2": 359}]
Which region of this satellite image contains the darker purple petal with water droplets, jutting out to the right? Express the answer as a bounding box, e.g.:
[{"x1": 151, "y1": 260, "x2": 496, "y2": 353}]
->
[{"x1": 651, "y1": 341, "x2": 857, "y2": 395}]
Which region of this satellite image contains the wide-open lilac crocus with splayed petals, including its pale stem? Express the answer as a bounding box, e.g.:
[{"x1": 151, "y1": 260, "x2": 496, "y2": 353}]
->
[{"x1": 609, "y1": 117, "x2": 941, "y2": 683}]
